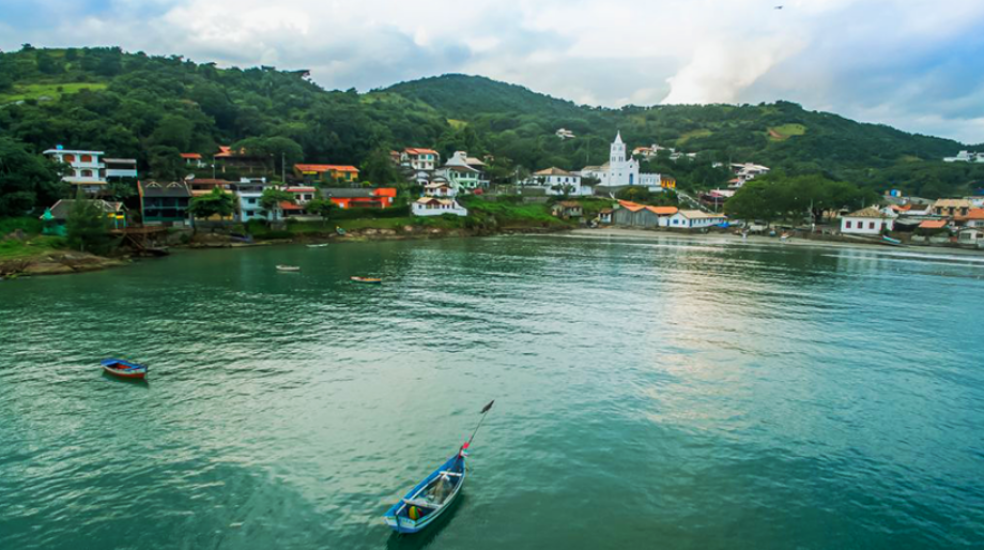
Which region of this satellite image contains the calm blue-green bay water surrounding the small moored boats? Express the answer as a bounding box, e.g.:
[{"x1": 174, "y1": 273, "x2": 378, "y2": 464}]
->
[{"x1": 0, "y1": 236, "x2": 984, "y2": 550}]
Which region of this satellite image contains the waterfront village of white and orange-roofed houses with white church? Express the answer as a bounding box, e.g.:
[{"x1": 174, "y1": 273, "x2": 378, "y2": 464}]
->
[{"x1": 9, "y1": 135, "x2": 984, "y2": 276}]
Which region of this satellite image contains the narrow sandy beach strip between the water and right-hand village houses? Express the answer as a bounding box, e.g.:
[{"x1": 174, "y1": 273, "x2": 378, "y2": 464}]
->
[{"x1": 568, "y1": 227, "x2": 984, "y2": 257}]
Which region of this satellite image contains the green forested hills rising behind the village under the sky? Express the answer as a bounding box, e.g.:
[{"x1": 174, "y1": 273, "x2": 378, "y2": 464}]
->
[{"x1": 0, "y1": 47, "x2": 984, "y2": 217}]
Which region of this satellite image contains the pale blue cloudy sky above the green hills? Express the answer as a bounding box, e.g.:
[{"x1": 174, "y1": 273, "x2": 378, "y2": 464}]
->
[{"x1": 0, "y1": 0, "x2": 984, "y2": 144}]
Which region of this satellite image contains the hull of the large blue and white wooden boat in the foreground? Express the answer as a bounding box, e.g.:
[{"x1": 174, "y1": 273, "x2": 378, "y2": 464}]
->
[{"x1": 383, "y1": 449, "x2": 466, "y2": 533}]
